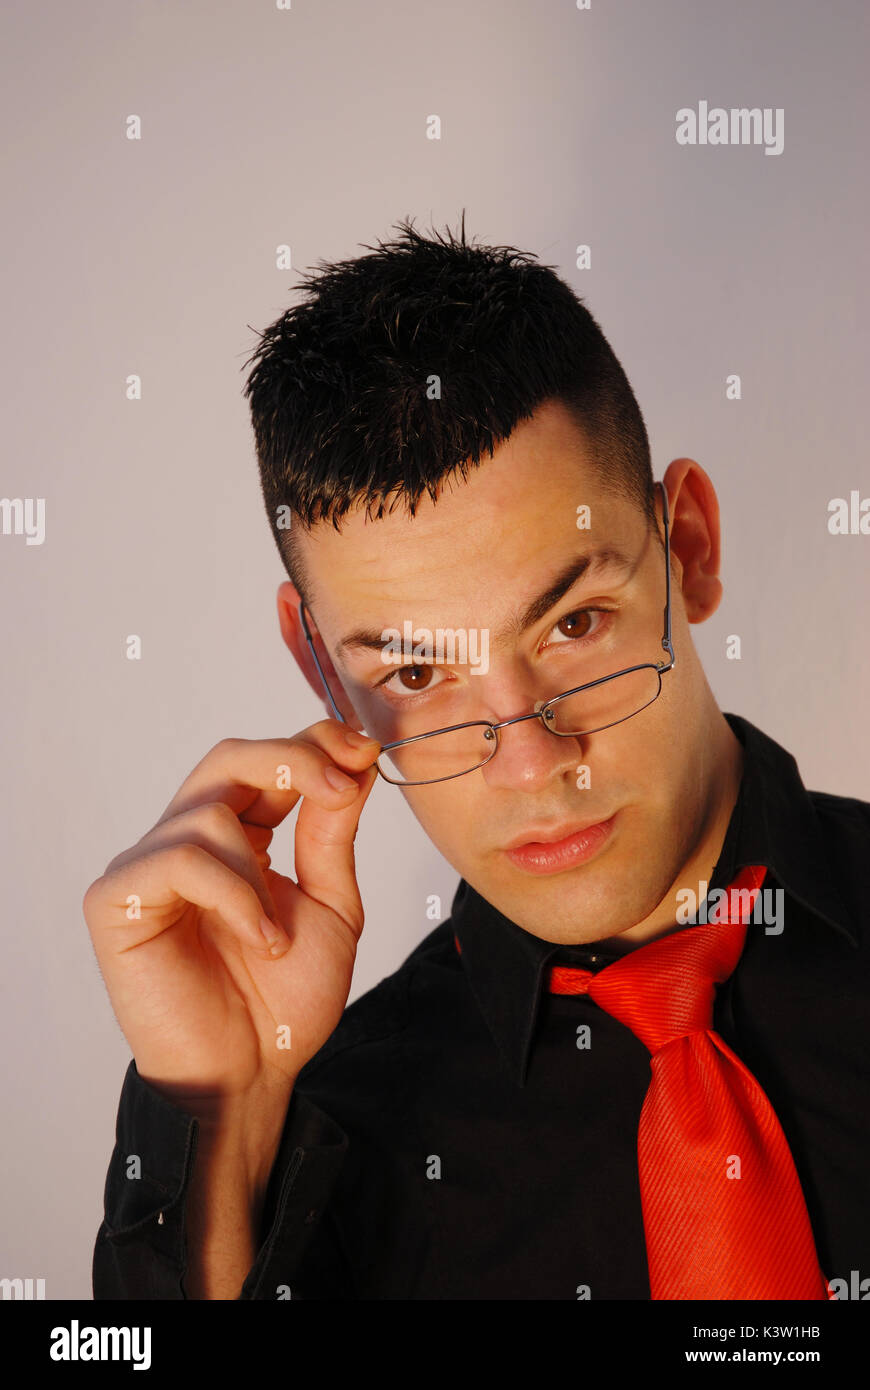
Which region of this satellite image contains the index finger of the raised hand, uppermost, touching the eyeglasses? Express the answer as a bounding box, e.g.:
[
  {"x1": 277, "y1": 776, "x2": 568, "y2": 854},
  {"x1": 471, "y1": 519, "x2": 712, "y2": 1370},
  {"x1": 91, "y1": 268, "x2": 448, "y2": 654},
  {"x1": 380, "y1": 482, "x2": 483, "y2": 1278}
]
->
[{"x1": 151, "y1": 719, "x2": 379, "y2": 828}]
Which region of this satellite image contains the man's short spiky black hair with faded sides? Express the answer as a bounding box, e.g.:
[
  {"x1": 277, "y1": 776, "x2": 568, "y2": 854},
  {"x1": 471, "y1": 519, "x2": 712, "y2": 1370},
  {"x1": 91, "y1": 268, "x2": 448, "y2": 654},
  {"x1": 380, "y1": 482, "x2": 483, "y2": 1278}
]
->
[{"x1": 243, "y1": 210, "x2": 655, "y2": 594}]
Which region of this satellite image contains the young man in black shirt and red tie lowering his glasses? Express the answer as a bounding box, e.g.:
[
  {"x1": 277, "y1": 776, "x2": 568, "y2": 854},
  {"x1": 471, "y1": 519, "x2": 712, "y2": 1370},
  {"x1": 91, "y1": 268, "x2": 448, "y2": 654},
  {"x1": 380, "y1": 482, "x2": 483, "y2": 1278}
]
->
[{"x1": 85, "y1": 222, "x2": 870, "y2": 1300}]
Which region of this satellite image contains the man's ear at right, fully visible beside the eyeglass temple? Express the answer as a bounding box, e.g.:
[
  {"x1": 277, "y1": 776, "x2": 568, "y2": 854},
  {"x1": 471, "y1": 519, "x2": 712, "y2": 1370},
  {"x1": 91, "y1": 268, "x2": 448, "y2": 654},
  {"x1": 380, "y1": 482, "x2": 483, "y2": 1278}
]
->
[{"x1": 664, "y1": 459, "x2": 723, "y2": 623}]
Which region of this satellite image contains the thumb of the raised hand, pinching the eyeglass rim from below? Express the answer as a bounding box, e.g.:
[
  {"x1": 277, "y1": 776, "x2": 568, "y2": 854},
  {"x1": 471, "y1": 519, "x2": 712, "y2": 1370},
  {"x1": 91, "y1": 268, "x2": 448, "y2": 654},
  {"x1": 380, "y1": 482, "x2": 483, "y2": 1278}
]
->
[{"x1": 295, "y1": 765, "x2": 378, "y2": 937}]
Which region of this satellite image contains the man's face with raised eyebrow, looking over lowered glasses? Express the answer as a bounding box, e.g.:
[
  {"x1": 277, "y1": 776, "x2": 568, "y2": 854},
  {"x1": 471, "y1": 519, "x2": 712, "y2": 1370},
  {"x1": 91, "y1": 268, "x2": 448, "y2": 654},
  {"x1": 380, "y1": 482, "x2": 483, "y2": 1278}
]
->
[{"x1": 289, "y1": 402, "x2": 714, "y2": 941}]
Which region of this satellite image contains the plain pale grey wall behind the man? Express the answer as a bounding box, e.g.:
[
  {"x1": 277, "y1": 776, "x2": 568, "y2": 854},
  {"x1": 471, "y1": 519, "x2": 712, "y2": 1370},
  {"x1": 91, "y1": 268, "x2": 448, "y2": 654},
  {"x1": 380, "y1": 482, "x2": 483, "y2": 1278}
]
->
[{"x1": 0, "y1": 0, "x2": 870, "y2": 1298}]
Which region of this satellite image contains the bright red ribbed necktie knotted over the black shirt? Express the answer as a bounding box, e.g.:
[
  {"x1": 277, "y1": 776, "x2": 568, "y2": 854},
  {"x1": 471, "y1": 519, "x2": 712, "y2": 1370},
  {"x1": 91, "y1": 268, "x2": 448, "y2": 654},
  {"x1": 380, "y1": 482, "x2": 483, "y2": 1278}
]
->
[{"x1": 549, "y1": 867, "x2": 831, "y2": 1300}]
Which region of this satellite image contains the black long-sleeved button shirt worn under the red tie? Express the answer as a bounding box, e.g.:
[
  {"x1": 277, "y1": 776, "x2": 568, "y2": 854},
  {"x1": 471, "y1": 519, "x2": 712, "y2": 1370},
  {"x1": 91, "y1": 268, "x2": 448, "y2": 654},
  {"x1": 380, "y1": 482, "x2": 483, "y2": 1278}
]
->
[{"x1": 93, "y1": 714, "x2": 870, "y2": 1300}]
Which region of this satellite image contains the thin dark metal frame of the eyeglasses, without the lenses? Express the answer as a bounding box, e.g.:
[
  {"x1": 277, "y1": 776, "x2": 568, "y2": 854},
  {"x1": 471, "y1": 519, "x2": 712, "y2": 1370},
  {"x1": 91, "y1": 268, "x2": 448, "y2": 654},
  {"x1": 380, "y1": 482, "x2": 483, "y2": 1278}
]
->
[{"x1": 299, "y1": 482, "x2": 675, "y2": 787}]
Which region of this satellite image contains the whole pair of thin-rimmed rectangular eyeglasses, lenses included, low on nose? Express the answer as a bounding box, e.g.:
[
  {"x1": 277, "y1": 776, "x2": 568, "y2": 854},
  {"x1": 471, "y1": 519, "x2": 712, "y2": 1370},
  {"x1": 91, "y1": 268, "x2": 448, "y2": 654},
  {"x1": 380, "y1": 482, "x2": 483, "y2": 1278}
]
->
[{"x1": 299, "y1": 482, "x2": 674, "y2": 787}]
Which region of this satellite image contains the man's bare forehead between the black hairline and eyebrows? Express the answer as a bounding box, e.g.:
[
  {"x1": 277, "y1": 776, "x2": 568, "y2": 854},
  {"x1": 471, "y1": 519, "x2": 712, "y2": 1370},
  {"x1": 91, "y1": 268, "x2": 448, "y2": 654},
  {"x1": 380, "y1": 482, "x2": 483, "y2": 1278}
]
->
[{"x1": 296, "y1": 402, "x2": 643, "y2": 641}]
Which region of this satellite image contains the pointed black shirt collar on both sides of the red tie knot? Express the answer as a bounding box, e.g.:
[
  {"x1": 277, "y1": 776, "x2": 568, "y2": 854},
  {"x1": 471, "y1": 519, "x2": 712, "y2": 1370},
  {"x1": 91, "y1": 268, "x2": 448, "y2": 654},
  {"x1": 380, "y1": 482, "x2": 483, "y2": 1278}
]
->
[{"x1": 450, "y1": 714, "x2": 859, "y2": 1086}]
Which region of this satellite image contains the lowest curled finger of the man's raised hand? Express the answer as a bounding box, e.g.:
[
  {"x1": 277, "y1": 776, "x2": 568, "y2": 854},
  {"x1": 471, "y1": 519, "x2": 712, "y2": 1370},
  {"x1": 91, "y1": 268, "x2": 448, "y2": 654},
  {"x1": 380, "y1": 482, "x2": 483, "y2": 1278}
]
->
[{"x1": 83, "y1": 844, "x2": 286, "y2": 956}]
